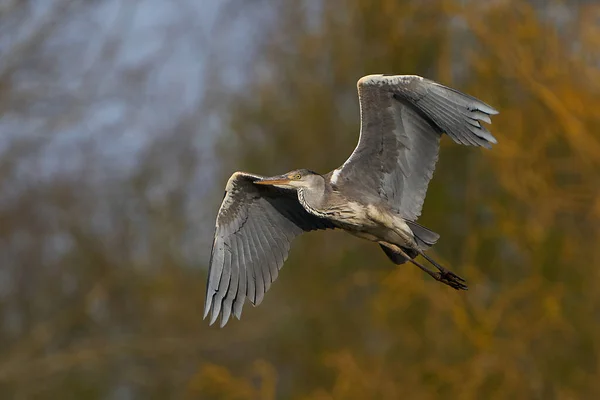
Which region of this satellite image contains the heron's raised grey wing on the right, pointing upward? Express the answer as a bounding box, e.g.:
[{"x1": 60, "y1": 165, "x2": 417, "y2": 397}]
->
[{"x1": 332, "y1": 75, "x2": 498, "y2": 221}]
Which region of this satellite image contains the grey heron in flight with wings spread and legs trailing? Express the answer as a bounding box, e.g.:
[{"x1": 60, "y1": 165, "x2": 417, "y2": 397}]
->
[{"x1": 204, "y1": 75, "x2": 498, "y2": 327}]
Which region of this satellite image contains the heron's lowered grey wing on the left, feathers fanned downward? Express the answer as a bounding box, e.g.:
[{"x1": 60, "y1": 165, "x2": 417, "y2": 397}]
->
[{"x1": 204, "y1": 172, "x2": 334, "y2": 326}]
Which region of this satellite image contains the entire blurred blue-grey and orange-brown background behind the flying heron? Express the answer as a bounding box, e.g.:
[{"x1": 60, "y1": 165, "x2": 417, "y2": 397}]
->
[{"x1": 0, "y1": 0, "x2": 600, "y2": 400}]
